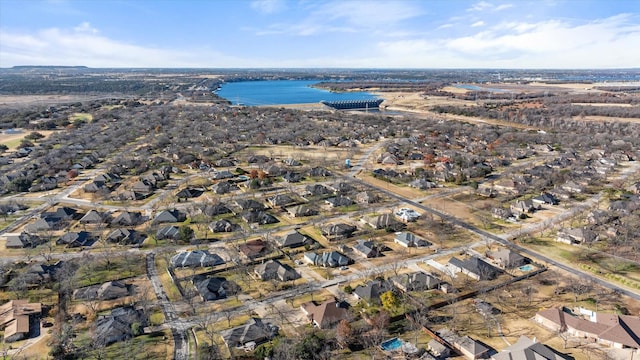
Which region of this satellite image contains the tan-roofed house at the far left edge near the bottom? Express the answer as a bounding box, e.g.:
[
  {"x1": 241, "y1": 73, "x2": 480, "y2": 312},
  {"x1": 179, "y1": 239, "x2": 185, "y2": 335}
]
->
[{"x1": 0, "y1": 299, "x2": 42, "y2": 342}]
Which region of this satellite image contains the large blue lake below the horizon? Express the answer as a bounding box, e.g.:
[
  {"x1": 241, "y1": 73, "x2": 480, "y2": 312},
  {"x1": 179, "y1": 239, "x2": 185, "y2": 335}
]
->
[{"x1": 216, "y1": 80, "x2": 378, "y2": 106}]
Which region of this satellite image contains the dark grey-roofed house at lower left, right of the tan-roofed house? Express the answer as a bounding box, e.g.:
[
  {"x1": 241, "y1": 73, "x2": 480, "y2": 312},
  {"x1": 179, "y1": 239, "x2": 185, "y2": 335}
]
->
[{"x1": 93, "y1": 306, "x2": 146, "y2": 345}]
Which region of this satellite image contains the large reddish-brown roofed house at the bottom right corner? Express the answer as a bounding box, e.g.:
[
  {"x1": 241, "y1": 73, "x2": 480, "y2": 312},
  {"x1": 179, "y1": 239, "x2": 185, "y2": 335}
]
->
[{"x1": 534, "y1": 308, "x2": 640, "y2": 349}]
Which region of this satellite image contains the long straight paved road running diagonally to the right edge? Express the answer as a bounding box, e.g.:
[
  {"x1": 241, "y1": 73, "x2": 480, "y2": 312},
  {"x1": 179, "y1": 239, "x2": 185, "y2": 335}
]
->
[{"x1": 345, "y1": 177, "x2": 640, "y2": 300}]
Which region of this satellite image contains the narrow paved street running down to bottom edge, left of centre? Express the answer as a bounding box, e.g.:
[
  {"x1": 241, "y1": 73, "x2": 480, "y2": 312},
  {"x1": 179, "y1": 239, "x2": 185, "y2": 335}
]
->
[{"x1": 147, "y1": 253, "x2": 189, "y2": 360}]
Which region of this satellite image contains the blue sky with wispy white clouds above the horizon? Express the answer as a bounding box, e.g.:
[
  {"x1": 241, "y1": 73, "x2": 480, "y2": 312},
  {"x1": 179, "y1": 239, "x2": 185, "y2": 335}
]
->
[{"x1": 0, "y1": 0, "x2": 640, "y2": 68}]
